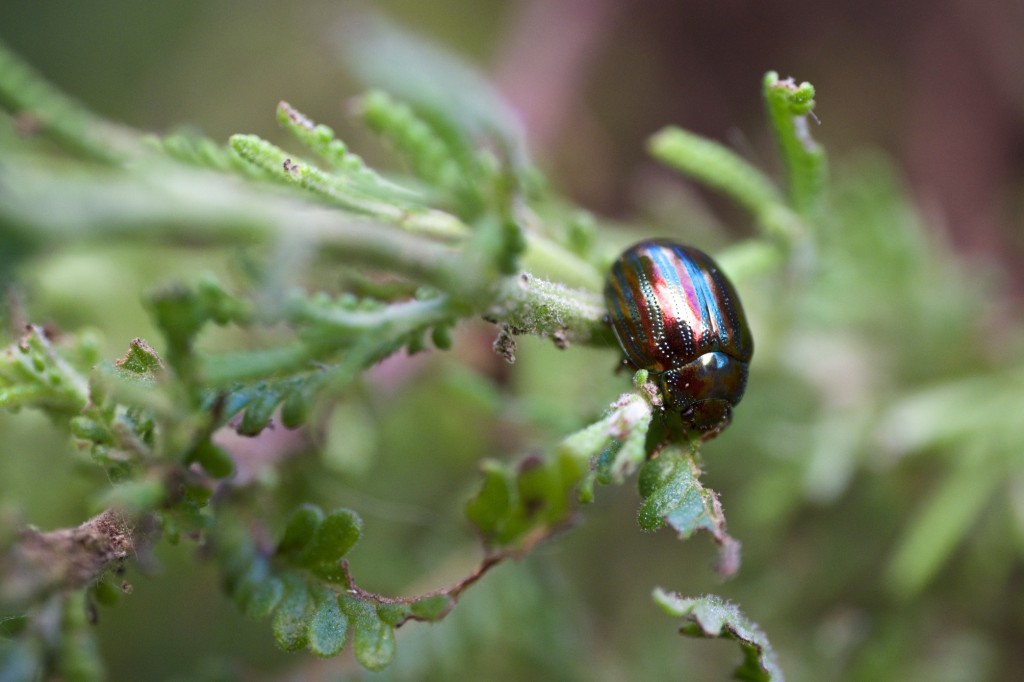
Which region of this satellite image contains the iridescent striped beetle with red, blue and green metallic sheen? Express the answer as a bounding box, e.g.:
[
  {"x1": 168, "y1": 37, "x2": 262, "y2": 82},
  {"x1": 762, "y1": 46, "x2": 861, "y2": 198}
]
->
[{"x1": 604, "y1": 240, "x2": 754, "y2": 439}]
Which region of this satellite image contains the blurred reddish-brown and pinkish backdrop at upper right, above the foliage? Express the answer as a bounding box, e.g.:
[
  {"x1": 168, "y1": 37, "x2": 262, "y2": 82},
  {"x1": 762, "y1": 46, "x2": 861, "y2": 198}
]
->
[{"x1": 493, "y1": 0, "x2": 1024, "y2": 291}]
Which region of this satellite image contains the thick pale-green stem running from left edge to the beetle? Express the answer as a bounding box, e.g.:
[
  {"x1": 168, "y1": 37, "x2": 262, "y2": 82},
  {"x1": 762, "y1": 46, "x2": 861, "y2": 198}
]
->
[{"x1": 0, "y1": 162, "x2": 604, "y2": 346}]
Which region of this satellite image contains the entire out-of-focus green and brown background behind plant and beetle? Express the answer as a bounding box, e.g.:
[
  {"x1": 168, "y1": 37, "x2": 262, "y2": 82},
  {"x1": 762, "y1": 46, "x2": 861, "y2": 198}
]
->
[{"x1": 0, "y1": 0, "x2": 1024, "y2": 682}]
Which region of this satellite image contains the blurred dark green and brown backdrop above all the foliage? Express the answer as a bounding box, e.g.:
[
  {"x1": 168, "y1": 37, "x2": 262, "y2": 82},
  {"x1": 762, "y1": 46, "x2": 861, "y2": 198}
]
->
[{"x1": 0, "y1": 0, "x2": 1024, "y2": 286}]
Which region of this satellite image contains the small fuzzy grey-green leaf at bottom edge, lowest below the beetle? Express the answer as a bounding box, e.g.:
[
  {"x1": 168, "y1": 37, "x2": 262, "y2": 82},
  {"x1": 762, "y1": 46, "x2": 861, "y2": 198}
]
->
[{"x1": 654, "y1": 588, "x2": 782, "y2": 682}]
